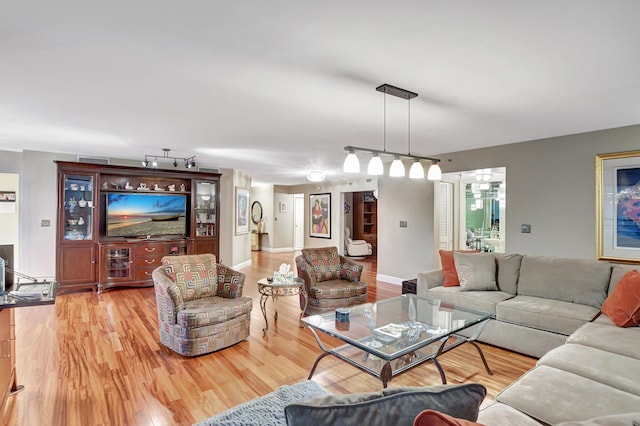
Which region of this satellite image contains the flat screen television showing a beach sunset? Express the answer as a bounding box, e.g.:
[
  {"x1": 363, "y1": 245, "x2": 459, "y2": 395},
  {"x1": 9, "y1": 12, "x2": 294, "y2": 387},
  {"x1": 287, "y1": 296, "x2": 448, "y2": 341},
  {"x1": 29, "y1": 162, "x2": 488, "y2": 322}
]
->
[{"x1": 106, "y1": 192, "x2": 187, "y2": 238}]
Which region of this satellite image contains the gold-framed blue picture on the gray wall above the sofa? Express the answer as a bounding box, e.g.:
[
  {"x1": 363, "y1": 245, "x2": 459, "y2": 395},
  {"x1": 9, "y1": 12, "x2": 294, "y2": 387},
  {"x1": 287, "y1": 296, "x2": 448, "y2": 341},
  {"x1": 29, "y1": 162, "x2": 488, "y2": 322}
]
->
[{"x1": 596, "y1": 151, "x2": 640, "y2": 263}]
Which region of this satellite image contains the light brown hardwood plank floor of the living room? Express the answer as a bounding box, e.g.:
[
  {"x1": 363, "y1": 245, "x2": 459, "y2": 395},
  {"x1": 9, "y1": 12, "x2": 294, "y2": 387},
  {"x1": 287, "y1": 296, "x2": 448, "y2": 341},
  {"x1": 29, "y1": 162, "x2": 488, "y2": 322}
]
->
[{"x1": 0, "y1": 252, "x2": 535, "y2": 426}]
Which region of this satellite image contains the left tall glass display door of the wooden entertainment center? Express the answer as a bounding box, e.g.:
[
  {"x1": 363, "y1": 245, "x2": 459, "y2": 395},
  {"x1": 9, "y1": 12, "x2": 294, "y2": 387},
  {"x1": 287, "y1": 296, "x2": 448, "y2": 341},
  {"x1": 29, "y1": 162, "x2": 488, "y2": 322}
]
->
[{"x1": 63, "y1": 174, "x2": 95, "y2": 240}]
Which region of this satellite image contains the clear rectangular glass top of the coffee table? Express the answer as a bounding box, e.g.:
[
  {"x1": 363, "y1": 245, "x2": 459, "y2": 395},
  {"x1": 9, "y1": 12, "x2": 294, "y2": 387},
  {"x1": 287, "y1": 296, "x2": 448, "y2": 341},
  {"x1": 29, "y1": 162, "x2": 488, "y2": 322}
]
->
[{"x1": 302, "y1": 294, "x2": 492, "y2": 364}]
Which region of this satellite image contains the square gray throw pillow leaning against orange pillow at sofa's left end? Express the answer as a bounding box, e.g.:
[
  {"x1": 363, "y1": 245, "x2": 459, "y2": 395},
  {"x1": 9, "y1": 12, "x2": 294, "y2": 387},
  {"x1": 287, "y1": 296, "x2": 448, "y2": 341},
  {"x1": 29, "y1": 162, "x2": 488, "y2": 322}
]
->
[{"x1": 453, "y1": 252, "x2": 498, "y2": 291}]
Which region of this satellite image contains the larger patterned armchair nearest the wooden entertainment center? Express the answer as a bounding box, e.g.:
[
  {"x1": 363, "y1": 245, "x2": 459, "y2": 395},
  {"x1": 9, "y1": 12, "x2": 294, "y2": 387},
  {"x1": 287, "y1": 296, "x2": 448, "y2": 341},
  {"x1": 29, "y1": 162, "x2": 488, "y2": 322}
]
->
[{"x1": 152, "y1": 254, "x2": 253, "y2": 356}]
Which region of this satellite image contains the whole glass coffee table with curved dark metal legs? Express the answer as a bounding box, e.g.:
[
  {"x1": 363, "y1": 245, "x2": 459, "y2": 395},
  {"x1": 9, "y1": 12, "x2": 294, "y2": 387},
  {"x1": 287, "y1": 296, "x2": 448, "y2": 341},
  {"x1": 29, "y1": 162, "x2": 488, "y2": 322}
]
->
[{"x1": 302, "y1": 294, "x2": 493, "y2": 388}]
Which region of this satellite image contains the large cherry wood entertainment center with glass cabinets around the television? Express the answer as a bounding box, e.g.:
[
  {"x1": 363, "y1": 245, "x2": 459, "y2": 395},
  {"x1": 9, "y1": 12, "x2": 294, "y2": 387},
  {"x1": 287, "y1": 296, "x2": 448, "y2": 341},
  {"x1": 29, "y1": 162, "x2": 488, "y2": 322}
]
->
[{"x1": 56, "y1": 161, "x2": 220, "y2": 293}]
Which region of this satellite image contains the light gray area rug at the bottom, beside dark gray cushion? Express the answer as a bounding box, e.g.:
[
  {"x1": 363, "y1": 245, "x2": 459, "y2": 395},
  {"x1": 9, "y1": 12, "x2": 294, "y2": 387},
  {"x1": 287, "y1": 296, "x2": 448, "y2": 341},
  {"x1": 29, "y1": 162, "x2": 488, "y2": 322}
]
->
[{"x1": 195, "y1": 380, "x2": 329, "y2": 426}]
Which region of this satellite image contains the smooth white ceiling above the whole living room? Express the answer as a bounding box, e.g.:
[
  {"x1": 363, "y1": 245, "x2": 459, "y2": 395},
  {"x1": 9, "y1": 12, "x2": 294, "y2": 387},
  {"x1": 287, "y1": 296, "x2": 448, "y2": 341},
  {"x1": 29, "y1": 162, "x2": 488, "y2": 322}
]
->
[{"x1": 0, "y1": 0, "x2": 640, "y2": 184}]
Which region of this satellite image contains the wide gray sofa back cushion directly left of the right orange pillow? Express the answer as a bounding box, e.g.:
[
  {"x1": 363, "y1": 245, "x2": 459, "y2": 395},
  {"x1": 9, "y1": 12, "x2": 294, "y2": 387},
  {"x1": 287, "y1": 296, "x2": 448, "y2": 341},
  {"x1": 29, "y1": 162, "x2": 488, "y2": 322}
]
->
[{"x1": 518, "y1": 255, "x2": 611, "y2": 309}]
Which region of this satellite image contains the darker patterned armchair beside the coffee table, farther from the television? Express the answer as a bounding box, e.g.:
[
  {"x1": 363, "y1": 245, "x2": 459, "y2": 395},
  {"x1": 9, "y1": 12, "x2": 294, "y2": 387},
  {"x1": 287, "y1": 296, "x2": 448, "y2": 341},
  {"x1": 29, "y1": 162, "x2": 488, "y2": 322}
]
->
[{"x1": 296, "y1": 247, "x2": 367, "y2": 315}]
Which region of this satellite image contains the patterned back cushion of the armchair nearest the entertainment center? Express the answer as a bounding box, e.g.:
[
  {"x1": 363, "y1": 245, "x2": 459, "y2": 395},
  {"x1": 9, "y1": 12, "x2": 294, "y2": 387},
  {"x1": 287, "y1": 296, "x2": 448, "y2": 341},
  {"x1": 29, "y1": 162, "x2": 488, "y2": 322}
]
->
[{"x1": 162, "y1": 254, "x2": 218, "y2": 302}]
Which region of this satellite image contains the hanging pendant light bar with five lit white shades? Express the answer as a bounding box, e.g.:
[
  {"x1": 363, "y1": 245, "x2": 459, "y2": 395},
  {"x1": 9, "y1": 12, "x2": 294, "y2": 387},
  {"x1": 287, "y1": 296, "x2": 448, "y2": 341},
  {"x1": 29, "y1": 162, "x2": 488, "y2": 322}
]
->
[{"x1": 343, "y1": 84, "x2": 442, "y2": 180}]
